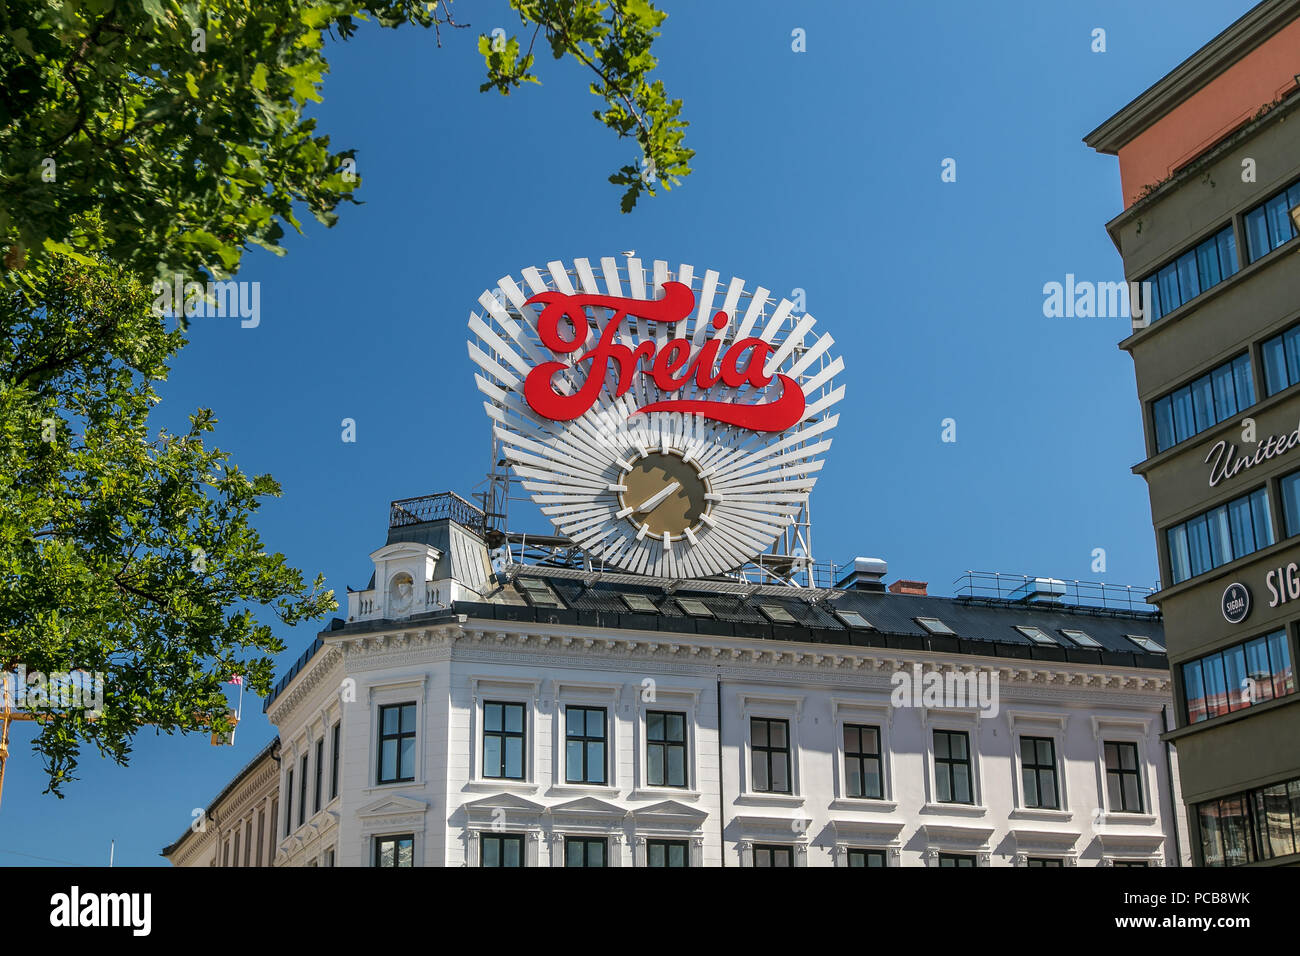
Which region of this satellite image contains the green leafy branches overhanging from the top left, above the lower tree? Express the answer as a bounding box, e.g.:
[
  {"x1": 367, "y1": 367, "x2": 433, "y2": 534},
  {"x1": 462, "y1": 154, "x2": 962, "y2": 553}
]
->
[{"x1": 0, "y1": 0, "x2": 692, "y2": 283}]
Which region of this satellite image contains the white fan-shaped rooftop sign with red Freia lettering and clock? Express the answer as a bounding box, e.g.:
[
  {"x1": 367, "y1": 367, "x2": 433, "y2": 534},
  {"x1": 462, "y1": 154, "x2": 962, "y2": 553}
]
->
[{"x1": 469, "y1": 258, "x2": 844, "y2": 578}]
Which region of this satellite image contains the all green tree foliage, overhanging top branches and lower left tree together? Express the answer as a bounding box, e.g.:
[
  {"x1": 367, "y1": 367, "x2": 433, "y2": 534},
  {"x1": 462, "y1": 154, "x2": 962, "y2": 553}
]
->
[{"x1": 0, "y1": 0, "x2": 692, "y2": 793}]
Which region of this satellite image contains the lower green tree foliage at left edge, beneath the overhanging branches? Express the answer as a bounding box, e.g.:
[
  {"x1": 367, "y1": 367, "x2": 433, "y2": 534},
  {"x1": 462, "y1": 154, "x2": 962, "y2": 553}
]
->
[{"x1": 0, "y1": 255, "x2": 337, "y2": 793}]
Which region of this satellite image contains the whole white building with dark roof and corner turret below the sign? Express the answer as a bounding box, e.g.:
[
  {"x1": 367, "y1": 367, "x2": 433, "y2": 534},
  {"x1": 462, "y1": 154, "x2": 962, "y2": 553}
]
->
[{"x1": 178, "y1": 494, "x2": 1187, "y2": 868}]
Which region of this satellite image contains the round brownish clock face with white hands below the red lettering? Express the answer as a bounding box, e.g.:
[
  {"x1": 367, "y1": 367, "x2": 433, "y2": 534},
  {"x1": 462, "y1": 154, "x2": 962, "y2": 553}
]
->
[{"x1": 618, "y1": 451, "x2": 709, "y2": 541}]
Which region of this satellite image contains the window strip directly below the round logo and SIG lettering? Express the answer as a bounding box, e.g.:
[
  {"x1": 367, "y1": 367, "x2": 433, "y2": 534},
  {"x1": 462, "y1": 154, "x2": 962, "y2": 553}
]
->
[{"x1": 1183, "y1": 631, "x2": 1296, "y2": 723}]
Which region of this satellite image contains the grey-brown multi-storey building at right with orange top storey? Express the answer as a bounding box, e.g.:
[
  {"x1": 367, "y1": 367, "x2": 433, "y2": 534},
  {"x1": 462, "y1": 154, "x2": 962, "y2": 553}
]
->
[{"x1": 1086, "y1": 0, "x2": 1300, "y2": 865}]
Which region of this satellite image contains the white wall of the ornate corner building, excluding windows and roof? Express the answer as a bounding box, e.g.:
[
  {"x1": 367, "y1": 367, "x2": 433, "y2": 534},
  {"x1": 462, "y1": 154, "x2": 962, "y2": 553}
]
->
[{"x1": 270, "y1": 622, "x2": 1187, "y2": 866}]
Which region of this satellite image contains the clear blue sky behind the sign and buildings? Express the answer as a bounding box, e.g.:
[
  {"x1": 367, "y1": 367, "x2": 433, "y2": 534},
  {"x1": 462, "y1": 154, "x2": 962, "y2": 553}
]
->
[{"x1": 0, "y1": 0, "x2": 1252, "y2": 865}]
